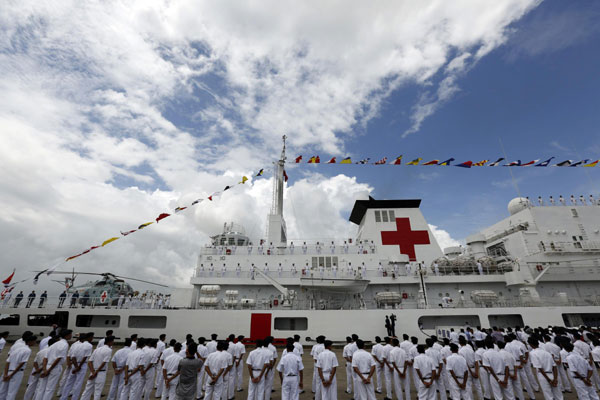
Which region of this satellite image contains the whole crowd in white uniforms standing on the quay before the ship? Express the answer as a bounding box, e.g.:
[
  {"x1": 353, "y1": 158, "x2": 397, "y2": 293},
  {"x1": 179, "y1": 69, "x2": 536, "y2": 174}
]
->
[{"x1": 0, "y1": 327, "x2": 600, "y2": 400}]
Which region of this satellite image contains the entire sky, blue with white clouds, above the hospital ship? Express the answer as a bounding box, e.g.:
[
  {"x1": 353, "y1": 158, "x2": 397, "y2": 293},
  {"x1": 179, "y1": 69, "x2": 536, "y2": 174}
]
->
[{"x1": 0, "y1": 0, "x2": 600, "y2": 285}]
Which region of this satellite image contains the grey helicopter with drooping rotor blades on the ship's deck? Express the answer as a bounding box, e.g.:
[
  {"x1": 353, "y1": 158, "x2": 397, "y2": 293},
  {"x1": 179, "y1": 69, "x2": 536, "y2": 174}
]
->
[{"x1": 47, "y1": 270, "x2": 169, "y2": 305}]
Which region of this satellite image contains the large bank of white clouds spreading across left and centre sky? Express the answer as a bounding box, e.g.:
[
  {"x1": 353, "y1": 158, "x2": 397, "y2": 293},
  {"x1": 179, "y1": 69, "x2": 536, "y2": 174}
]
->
[{"x1": 0, "y1": 0, "x2": 537, "y2": 292}]
